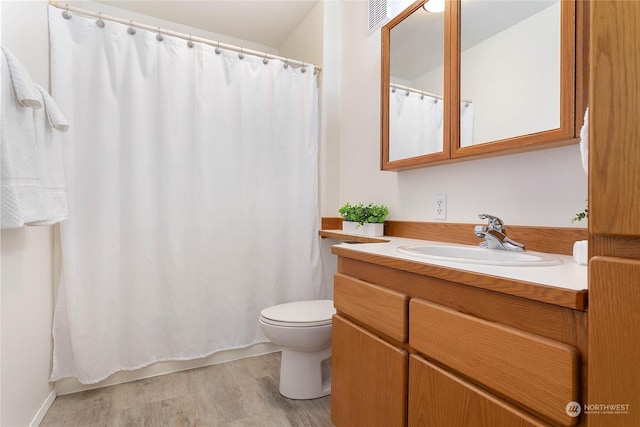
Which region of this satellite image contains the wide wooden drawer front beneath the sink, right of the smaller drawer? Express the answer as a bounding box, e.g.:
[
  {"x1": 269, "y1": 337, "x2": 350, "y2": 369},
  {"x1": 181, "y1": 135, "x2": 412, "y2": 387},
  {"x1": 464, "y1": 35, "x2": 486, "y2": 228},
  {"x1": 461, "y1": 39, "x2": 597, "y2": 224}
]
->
[{"x1": 409, "y1": 299, "x2": 579, "y2": 426}]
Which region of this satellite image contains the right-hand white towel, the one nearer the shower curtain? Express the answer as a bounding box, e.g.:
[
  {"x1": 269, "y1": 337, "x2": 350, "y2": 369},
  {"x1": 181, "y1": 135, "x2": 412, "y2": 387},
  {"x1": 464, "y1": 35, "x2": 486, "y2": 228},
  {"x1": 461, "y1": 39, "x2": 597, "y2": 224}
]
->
[{"x1": 27, "y1": 84, "x2": 69, "y2": 225}]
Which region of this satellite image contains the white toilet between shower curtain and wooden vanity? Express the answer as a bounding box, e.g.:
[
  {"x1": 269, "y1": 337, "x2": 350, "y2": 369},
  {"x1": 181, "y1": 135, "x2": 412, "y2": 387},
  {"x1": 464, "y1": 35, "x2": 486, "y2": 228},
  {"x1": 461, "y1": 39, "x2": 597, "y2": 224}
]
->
[{"x1": 260, "y1": 300, "x2": 336, "y2": 399}]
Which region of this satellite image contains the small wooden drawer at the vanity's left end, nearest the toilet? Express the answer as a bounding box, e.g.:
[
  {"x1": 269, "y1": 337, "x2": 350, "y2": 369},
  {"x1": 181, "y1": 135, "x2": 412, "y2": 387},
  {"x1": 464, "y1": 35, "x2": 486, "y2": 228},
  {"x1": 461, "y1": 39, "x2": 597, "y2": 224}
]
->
[{"x1": 333, "y1": 273, "x2": 409, "y2": 342}]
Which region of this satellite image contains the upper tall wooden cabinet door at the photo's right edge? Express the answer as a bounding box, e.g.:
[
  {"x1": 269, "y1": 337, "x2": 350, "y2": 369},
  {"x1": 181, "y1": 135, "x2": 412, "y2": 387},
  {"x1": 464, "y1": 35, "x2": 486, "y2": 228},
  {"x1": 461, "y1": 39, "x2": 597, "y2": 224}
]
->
[{"x1": 589, "y1": 1, "x2": 640, "y2": 237}]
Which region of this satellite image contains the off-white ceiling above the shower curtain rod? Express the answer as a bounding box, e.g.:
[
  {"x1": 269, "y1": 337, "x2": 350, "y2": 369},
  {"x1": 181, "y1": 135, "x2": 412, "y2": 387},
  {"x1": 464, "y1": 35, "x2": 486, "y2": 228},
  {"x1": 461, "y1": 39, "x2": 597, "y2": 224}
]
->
[{"x1": 92, "y1": 0, "x2": 319, "y2": 49}]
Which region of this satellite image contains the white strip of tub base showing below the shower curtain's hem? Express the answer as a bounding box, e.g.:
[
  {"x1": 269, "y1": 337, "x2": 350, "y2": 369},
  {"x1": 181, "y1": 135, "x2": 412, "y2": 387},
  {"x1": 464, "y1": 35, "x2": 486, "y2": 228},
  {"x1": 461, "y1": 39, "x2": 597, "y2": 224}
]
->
[{"x1": 52, "y1": 342, "x2": 281, "y2": 396}]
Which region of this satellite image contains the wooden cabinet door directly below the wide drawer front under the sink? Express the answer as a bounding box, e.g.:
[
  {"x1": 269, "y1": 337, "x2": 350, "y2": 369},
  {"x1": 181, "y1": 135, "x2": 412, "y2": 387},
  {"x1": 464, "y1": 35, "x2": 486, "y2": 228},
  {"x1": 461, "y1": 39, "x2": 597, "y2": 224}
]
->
[{"x1": 409, "y1": 355, "x2": 548, "y2": 427}]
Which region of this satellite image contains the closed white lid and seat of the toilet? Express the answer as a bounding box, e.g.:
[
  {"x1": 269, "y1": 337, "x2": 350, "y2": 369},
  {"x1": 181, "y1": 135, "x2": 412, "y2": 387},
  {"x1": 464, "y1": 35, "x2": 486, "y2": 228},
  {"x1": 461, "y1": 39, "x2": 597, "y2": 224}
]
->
[{"x1": 260, "y1": 300, "x2": 336, "y2": 327}]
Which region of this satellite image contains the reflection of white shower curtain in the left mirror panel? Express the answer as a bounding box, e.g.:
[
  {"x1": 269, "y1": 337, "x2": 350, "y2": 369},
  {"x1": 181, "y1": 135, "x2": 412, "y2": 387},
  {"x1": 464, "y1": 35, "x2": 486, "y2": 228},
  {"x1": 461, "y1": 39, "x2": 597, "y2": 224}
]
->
[{"x1": 389, "y1": 89, "x2": 443, "y2": 161}]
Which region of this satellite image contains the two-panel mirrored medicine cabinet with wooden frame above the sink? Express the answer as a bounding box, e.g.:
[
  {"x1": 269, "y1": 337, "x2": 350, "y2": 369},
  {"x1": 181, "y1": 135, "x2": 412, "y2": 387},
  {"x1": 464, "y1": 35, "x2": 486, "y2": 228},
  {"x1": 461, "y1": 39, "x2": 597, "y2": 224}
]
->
[{"x1": 381, "y1": 0, "x2": 588, "y2": 170}]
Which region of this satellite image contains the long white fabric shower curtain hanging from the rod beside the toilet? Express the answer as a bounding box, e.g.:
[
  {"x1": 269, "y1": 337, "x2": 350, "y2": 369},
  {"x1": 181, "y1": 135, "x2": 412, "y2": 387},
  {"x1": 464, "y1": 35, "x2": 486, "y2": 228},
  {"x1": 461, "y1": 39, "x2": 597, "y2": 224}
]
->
[{"x1": 49, "y1": 7, "x2": 322, "y2": 384}]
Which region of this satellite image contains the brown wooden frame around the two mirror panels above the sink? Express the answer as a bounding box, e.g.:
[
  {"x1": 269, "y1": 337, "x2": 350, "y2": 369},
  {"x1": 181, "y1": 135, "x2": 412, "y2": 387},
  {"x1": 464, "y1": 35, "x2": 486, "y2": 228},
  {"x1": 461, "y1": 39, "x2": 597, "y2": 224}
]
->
[{"x1": 380, "y1": 0, "x2": 589, "y2": 170}]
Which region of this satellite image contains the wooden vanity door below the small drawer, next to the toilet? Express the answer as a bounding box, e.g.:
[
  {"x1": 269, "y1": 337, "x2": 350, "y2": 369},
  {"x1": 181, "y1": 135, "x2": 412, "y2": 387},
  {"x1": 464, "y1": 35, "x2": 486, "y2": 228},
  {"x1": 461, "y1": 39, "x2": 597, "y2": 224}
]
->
[{"x1": 331, "y1": 315, "x2": 408, "y2": 427}]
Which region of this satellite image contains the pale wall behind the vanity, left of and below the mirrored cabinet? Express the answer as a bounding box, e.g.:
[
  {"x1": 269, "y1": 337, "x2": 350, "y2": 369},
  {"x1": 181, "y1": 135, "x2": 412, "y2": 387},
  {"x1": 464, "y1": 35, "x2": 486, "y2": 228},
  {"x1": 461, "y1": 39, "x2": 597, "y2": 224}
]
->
[{"x1": 330, "y1": 1, "x2": 587, "y2": 229}]
